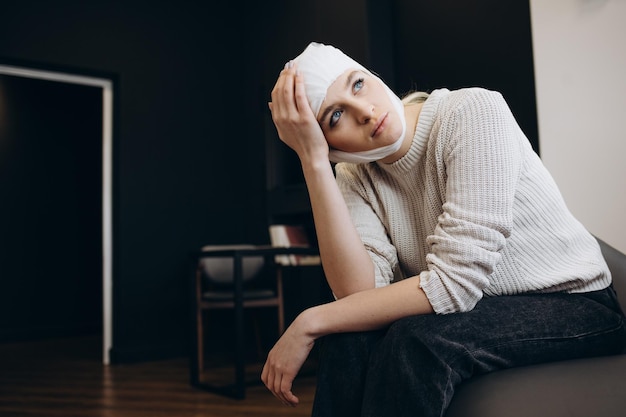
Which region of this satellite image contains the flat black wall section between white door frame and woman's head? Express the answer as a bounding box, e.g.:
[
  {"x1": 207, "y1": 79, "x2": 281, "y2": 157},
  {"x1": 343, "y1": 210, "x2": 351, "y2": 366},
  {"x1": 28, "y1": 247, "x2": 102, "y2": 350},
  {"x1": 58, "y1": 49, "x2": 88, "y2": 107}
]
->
[{"x1": 0, "y1": 0, "x2": 267, "y2": 361}]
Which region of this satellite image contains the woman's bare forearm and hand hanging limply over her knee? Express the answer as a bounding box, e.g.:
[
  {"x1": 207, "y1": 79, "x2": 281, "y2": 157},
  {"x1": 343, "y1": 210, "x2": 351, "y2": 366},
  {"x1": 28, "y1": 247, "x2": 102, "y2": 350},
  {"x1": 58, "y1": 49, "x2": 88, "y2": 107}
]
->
[{"x1": 261, "y1": 276, "x2": 433, "y2": 406}]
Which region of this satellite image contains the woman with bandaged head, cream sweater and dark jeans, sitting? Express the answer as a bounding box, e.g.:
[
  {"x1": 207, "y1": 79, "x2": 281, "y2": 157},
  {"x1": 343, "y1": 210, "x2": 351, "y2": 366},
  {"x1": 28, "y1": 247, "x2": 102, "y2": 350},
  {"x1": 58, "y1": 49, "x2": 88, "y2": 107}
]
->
[{"x1": 261, "y1": 43, "x2": 626, "y2": 417}]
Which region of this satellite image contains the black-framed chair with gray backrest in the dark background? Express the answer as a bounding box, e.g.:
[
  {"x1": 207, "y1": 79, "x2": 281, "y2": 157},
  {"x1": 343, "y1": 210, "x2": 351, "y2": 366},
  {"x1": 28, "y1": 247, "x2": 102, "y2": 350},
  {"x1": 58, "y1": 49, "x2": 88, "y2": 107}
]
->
[{"x1": 190, "y1": 245, "x2": 317, "y2": 399}]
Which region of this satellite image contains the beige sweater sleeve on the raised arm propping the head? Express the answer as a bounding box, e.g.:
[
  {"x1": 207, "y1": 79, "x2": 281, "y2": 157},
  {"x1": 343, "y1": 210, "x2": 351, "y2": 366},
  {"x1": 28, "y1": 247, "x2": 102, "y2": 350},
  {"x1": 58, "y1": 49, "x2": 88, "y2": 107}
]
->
[{"x1": 336, "y1": 163, "x2": 398, "y2": 287}]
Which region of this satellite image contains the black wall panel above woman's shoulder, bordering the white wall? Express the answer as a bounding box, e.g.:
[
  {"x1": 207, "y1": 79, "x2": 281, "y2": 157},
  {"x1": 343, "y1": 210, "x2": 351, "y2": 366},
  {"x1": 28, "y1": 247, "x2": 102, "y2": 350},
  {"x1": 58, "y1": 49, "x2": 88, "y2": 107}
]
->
[{"x1": 392, "y1": 0, "x2": 539, "y2": 152}]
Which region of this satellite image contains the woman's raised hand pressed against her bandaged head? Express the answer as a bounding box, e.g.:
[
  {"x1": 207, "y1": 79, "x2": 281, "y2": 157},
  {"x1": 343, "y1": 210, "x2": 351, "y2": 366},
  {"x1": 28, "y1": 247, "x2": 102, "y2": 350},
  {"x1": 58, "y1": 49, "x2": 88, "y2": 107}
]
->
[{"x1": 268, "y1": 62, "x2": 328, "y2": 164}]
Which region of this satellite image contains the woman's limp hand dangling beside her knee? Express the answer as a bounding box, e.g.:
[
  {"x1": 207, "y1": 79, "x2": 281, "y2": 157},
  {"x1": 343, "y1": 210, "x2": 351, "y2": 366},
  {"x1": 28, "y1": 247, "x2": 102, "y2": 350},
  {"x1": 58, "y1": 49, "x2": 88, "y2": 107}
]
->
[{"x1": 261, "y1": 311, "x2": 315, "y2": 407}]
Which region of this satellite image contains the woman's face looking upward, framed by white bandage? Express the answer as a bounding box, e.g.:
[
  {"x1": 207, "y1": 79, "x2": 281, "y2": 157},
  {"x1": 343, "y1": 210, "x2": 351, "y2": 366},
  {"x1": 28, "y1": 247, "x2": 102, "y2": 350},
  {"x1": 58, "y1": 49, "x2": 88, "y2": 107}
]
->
[{"x1": 317, "y1": 70, "x2": 402, "y2": 152}]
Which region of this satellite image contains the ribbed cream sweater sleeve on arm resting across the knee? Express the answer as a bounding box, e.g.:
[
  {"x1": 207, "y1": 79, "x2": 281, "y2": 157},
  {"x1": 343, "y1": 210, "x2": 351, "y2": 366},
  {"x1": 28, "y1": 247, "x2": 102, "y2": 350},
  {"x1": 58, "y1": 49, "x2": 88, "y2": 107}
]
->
[{"x1": 420, "y1": 89, "x2": 523, "y2": 314}]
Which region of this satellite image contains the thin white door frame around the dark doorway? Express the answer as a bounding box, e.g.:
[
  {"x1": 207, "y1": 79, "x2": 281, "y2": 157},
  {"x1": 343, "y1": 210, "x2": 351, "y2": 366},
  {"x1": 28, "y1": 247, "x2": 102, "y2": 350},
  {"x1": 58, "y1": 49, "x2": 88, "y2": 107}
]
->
[{"x1": 0, "y1": 64, "x2": 114, "y2": 365}]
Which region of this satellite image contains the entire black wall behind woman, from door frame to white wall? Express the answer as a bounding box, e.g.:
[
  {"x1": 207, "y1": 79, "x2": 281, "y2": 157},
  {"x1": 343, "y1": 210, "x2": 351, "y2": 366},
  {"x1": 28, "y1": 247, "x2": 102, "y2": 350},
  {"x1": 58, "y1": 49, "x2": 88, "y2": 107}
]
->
[{"x1": 0, "y1": 0, "x2": 536, "y2": 361}]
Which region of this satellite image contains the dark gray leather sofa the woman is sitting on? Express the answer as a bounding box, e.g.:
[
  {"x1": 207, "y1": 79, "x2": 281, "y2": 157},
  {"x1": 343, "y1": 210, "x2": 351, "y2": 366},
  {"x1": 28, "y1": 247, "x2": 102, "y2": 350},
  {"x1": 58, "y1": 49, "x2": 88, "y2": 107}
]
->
[{"x1": 446, "y1": 239, "x2": 626, "y2": 417}]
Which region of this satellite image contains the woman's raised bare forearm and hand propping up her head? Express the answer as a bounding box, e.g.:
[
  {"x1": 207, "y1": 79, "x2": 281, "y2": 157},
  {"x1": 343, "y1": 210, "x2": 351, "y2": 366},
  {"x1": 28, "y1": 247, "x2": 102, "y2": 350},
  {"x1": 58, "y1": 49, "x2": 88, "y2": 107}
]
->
[{"x1": 270, "y1": 64, "x2": 374, "y2": 298}]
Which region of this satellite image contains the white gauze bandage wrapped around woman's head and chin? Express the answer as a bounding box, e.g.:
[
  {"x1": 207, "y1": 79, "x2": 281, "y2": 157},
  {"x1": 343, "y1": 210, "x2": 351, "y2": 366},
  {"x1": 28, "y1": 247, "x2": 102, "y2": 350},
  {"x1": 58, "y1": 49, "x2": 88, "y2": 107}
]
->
[{"x1": 294, "y1": 42, "x2": 406, "y2": 164}]
